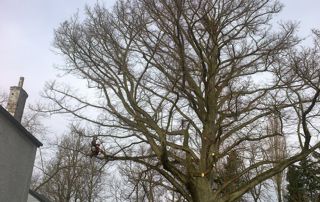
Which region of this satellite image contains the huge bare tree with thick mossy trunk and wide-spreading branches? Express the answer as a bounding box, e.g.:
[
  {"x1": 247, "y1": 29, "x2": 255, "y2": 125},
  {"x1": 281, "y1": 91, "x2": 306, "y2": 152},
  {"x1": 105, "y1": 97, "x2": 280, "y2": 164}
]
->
[{"x1": 40, "y1": 0, "x2": 320, "y2": 202}]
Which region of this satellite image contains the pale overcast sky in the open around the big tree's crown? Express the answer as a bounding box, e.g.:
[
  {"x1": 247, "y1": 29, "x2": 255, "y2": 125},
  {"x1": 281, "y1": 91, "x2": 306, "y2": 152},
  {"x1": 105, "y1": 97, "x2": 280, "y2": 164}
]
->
[{"x1": 0, "y1": 0, "x2": 320, "y2": 134}]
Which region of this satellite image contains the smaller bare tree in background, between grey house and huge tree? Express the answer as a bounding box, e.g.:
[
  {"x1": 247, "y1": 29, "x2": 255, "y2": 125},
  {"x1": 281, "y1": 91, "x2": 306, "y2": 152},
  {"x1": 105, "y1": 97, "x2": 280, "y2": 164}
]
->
[{"x1": 33, "y1": 127, "x2": 104, "y2": 202}]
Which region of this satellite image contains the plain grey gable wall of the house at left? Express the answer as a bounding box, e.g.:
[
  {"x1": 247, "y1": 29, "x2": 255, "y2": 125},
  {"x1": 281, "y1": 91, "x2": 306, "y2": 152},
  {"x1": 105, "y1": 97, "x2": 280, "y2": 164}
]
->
[{"x1": 0, "y1": 113, "x2": 37, "y2": 202}]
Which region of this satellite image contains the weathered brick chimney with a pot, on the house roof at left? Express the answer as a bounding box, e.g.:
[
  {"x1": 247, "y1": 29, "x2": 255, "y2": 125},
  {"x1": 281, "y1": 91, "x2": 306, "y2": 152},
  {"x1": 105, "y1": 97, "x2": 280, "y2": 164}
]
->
[{"x1": 7, "y1": 77, "x2": 28, "y2": 122}]
